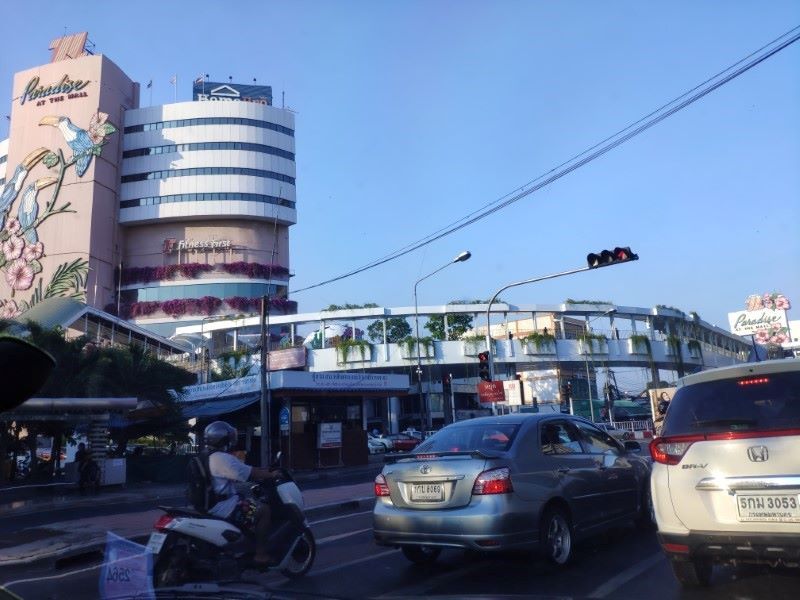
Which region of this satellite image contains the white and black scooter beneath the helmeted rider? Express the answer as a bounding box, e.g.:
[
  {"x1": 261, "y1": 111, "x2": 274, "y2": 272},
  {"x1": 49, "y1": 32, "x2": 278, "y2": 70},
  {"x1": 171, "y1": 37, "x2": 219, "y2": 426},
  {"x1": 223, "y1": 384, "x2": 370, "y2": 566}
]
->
[{"x1": 147, "y1": 453, "x2": 316, "y2": 588}]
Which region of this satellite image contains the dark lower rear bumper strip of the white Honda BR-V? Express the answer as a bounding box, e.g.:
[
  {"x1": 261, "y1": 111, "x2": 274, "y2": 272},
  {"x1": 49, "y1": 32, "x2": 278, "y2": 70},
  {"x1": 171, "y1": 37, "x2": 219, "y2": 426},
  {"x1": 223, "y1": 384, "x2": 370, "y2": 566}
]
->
[{"x1": 658, "y1": 531, "x2": 800, "y2": 566}]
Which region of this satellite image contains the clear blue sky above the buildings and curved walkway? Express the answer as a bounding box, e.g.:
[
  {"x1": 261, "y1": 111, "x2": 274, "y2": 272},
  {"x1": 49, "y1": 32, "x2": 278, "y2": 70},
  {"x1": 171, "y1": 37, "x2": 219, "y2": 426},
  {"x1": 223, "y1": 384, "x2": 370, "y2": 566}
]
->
[{"x1": 0, "y1": 0, "x2": 800, "y2": 328}]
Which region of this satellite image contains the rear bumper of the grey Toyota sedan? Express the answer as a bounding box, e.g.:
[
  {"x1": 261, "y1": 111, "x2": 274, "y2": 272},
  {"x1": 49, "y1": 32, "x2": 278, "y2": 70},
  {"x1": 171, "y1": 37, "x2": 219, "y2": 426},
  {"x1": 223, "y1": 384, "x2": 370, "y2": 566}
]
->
[{"x1": 373, "y1": 495, "x2": 539, "y2": 551}]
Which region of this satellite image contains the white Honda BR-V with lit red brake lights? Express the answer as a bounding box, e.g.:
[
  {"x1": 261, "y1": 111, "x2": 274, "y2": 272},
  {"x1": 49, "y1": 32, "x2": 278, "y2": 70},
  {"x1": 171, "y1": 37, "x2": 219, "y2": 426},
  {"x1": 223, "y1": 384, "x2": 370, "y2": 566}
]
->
[{"x1": 650, "y1": 359, "x2": 800, "y2": 586}]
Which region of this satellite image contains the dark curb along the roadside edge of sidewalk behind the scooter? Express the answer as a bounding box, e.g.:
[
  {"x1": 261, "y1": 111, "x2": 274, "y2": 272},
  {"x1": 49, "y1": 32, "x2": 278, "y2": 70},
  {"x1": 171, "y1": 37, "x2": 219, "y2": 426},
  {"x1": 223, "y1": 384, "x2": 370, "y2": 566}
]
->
[{"x1": 0, "y1": 496, "x2": 375, "y2": 574}]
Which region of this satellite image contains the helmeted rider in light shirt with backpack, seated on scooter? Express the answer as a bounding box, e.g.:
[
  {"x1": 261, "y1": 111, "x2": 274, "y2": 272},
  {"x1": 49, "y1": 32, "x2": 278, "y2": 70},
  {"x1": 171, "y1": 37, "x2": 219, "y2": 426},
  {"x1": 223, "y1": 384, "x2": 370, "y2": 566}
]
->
[{"x1": 203, "y1": 421, "x2": 275, "y2": 565}]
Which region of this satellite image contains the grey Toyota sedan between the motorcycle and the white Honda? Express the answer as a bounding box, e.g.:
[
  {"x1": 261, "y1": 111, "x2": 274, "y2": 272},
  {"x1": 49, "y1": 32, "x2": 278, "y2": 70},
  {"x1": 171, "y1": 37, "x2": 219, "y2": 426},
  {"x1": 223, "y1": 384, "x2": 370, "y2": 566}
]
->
[{"x1": 373, "y1": 413, "x2": 651, "y2": 565}]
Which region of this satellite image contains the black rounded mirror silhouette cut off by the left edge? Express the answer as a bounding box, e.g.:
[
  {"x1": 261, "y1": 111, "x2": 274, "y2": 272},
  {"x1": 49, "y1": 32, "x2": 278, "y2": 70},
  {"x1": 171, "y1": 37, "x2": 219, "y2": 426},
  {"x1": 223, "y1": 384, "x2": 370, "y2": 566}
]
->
[{"x1": 0, "y1": 337, "x2": 56, "y2": 413}]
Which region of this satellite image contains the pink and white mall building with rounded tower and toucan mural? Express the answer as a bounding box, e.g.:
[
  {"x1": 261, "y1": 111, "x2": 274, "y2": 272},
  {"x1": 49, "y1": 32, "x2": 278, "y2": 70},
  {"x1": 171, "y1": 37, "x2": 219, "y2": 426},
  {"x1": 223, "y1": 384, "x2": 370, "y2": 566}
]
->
[{"x1": 0, "y1": 34, "x2": 297, "y2": 337}]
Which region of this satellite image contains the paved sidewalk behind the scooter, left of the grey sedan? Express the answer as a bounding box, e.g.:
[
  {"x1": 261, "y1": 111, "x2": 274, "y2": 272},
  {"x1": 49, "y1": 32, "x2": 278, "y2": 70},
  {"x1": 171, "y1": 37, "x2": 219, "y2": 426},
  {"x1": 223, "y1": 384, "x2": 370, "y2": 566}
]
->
[{"x1": 0, "y1": 463, "x2": 380, "y2": 568}]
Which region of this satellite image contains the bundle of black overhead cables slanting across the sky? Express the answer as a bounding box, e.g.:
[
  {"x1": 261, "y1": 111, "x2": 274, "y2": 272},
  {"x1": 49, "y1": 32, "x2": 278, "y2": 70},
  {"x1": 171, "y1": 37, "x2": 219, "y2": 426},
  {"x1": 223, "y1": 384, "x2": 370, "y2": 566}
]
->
[{"x1": 292, "y1": 26, "x2": 800, "y2": 294}]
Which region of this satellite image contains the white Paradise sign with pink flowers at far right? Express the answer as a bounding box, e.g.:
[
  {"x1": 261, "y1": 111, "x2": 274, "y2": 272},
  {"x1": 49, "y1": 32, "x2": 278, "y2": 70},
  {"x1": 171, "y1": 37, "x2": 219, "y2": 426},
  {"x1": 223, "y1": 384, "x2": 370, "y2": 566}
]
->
[{"x1": 728, "y1": 292, "x2": 791, "y2": 345}]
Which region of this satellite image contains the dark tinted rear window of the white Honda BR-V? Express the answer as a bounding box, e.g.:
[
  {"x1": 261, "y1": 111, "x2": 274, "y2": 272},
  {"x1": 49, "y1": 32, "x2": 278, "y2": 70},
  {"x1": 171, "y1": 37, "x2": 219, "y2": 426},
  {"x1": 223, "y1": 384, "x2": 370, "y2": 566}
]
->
[{"x1": 662, "y1": 372, "x2": 800, "y2": 435}]
